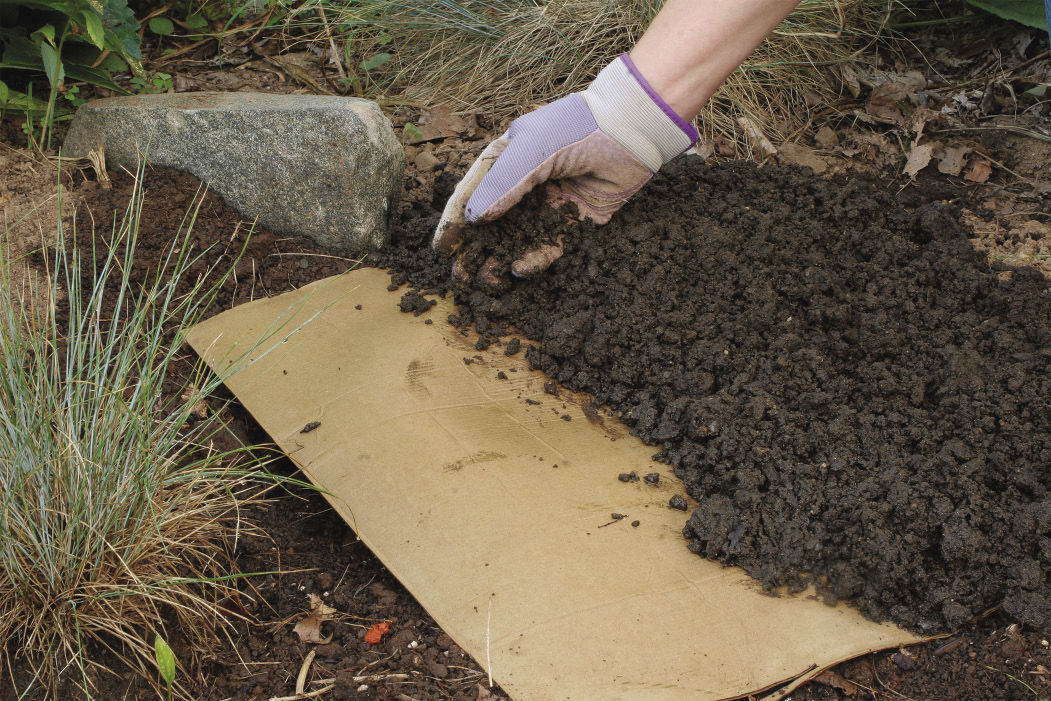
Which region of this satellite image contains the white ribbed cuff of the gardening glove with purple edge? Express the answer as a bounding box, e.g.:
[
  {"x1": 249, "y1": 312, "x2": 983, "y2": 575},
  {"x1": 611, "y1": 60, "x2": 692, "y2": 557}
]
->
[{"x1": 581, "y1": 54, "x2": 700, "y2": 172}]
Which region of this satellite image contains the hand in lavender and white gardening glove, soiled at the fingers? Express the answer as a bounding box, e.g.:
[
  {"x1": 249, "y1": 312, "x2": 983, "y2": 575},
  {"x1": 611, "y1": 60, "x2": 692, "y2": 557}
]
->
[{"x1": 432, "y1": 54, "x2": 698, "y2": 276}]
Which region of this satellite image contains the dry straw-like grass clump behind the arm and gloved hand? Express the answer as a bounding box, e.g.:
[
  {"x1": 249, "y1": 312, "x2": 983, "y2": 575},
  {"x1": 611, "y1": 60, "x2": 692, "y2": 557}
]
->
[{"x1": 329, "y1": 0, "x2": 890, "y2": 154}]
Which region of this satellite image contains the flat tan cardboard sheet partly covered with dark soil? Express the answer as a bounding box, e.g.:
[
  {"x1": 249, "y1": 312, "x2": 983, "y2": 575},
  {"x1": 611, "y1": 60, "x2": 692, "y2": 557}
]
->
[{"x1": 190, "y1": 269, "x2": 918, "y2": 701}]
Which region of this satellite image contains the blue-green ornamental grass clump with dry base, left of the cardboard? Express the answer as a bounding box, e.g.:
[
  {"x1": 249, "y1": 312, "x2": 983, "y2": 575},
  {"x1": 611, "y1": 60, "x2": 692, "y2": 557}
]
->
[{"x1": 0, "y1": 174, "x2": 261, "y2": 698}]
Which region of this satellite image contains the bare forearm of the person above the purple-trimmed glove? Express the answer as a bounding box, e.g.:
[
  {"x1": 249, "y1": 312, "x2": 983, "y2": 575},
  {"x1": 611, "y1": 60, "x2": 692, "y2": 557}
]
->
[{"x1": 631, "y1": 0, "x2": 800, "y2": 120}]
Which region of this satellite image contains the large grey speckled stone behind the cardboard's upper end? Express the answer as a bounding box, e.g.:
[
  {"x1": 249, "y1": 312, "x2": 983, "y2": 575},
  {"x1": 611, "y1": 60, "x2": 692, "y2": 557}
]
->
[{"x1": 63, "y1": 92, "x2": 406, "y2": 254}]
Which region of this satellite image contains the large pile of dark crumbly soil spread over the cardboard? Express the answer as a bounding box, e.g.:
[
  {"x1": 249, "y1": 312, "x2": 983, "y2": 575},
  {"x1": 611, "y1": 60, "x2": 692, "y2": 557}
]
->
[{"x1": 382, "y1": 159, "x2": 1051, "y2": 633}]
